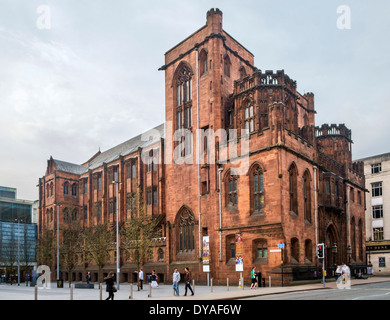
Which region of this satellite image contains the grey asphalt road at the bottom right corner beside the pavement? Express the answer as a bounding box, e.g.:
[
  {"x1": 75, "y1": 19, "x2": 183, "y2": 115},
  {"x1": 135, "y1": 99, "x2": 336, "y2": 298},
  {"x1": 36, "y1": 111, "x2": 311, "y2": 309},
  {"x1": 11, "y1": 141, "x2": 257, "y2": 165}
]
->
[{"x1": 243, "y1": 281, "x2": 390, "y2": 300}]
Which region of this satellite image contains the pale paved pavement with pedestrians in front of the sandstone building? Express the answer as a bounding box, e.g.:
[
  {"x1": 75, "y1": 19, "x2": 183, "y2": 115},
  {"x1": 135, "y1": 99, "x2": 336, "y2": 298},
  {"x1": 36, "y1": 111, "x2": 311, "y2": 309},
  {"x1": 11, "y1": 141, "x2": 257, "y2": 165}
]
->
[{"x1": 0, "y1": 276, "x2": 390, "y2": 301}]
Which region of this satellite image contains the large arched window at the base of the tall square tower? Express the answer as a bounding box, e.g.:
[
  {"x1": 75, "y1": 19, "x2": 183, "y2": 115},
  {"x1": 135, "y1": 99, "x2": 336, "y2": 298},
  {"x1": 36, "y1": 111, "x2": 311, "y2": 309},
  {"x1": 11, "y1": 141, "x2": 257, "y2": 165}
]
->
[{"x1": 177, "y1": 207, "x2": 196, "y2": 252}]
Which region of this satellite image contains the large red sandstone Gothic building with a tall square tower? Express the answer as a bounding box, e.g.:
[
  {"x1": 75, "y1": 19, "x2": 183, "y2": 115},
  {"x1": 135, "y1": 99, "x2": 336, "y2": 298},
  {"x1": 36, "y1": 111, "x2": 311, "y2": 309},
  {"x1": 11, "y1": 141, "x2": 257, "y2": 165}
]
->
[{"x1": 39, "y1": 9, "x2": 366, "y2": 284}]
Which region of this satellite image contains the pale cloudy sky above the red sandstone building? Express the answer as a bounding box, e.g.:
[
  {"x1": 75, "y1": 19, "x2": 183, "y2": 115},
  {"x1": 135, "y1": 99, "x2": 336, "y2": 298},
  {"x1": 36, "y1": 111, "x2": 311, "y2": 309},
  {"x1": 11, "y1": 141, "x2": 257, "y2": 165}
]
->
[{"x1": 0, "y1": 0, "x2": 390, "y2": 200}]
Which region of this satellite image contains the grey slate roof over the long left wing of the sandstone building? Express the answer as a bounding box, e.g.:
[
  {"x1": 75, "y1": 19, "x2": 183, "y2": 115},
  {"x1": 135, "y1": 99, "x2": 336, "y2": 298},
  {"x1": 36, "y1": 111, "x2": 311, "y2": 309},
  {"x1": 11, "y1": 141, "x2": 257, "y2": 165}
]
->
[{"x1": 53, "y1": 124, "x2": 165, "y2": 175}]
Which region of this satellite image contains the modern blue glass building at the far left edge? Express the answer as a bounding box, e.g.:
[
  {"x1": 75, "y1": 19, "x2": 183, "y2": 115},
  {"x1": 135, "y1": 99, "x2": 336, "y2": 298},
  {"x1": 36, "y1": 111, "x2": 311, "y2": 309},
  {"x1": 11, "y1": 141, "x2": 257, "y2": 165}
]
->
[{"x1": 0, "y1": 187, "x2": 38, "y2": 282}]
